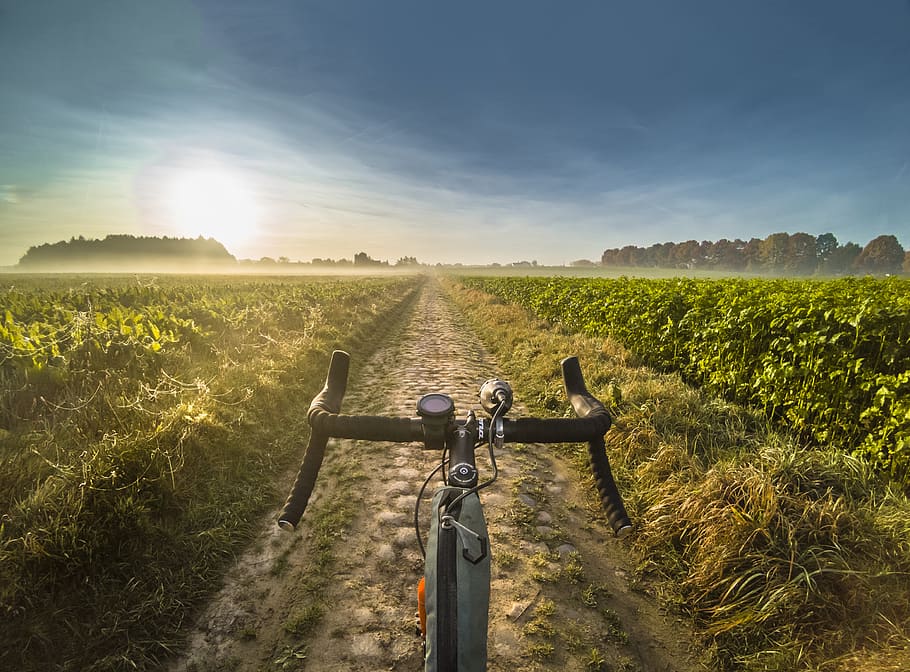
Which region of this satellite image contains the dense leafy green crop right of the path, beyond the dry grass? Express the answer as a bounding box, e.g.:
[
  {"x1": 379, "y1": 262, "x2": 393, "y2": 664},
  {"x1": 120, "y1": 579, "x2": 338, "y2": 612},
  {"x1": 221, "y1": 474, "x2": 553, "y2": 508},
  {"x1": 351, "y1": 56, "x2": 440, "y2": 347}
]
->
[{"x1": 465, "y1": 278, "x2": 910, "y2": 486}]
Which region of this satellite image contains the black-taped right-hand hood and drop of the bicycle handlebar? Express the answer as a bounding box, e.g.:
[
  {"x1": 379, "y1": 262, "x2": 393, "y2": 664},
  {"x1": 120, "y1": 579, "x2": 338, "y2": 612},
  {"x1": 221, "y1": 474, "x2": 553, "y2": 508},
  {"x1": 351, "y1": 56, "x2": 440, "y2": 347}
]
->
[{"x1": 562, "y1": 357, "x2": 632, "y2": 537}]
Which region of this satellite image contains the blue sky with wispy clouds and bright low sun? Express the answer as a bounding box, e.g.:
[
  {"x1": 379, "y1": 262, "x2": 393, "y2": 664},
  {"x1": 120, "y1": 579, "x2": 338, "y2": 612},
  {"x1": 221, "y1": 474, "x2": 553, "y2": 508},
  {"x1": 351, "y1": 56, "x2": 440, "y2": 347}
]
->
[{"x1": 0, "y1": 0, "x2": 910, "y2": 266}]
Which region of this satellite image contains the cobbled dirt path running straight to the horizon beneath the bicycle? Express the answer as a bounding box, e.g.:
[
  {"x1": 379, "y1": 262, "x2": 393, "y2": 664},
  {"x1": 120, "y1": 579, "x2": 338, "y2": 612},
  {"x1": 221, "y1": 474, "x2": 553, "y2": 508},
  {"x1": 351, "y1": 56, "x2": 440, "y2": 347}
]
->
[{"x1": 171, "y1": 282, "x2": 702, "y2": 672}]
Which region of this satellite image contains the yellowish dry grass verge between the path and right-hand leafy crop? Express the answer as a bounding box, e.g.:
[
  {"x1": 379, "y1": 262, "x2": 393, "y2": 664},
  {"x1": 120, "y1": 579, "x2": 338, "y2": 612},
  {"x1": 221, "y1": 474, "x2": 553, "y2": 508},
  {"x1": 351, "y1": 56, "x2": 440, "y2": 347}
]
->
[{"x1": 446, "y1": 281, "x2": 910, "y2": 671}]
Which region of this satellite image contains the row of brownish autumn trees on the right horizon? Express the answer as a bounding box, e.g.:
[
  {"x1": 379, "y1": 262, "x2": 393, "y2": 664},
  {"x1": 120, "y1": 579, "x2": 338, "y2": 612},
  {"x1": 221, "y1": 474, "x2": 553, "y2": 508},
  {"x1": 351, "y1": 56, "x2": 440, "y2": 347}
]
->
[{"x1": 601, "y1": 233, "x2": 910, "y2": 275}]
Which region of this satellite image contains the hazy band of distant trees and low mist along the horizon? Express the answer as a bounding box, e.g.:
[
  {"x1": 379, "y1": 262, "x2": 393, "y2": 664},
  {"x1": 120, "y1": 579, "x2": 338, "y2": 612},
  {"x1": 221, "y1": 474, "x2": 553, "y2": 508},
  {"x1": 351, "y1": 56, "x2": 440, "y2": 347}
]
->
[{"x1": 9, "y1": 227, "x2": 910, "y2": 276}]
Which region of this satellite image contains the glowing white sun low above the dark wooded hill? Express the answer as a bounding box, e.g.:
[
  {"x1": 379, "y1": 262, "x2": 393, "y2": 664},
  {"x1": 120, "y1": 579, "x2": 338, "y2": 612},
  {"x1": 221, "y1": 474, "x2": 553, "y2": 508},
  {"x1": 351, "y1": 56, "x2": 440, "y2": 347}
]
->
[{"x1": 167, "y1": 168, "x2": 260, "y2": 251}]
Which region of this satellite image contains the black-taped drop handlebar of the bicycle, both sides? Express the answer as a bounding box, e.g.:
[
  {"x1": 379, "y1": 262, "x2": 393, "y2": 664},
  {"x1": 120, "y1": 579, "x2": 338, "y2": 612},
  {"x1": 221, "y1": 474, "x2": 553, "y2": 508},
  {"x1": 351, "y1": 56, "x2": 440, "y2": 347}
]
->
[{"x1": 278, "y1": 350, "x2": 632, "y2": 537}]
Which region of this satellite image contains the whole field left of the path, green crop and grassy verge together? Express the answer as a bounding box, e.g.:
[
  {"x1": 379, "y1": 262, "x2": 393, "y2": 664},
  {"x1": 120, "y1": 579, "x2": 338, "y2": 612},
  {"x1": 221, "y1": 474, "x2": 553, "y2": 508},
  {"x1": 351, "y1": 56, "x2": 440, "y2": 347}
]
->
[{"x1": 0, "y1": 276, "x2": 419, "y2": 670}]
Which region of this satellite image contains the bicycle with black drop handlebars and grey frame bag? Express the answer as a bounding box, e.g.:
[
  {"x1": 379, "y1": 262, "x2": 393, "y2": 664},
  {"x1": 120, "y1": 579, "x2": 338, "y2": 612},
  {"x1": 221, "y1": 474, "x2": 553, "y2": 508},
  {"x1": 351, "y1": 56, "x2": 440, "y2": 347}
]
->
[{"x1": 278, "y1": 350, "x2": 632, "y2": 672}]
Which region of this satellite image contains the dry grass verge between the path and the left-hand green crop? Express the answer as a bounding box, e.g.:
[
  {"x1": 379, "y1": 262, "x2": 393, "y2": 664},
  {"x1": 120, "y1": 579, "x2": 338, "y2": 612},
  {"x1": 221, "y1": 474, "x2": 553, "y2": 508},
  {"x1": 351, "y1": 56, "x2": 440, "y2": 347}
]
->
[{"x1": 0, "y1": 279, "x2": 420, "y2": 670}]
